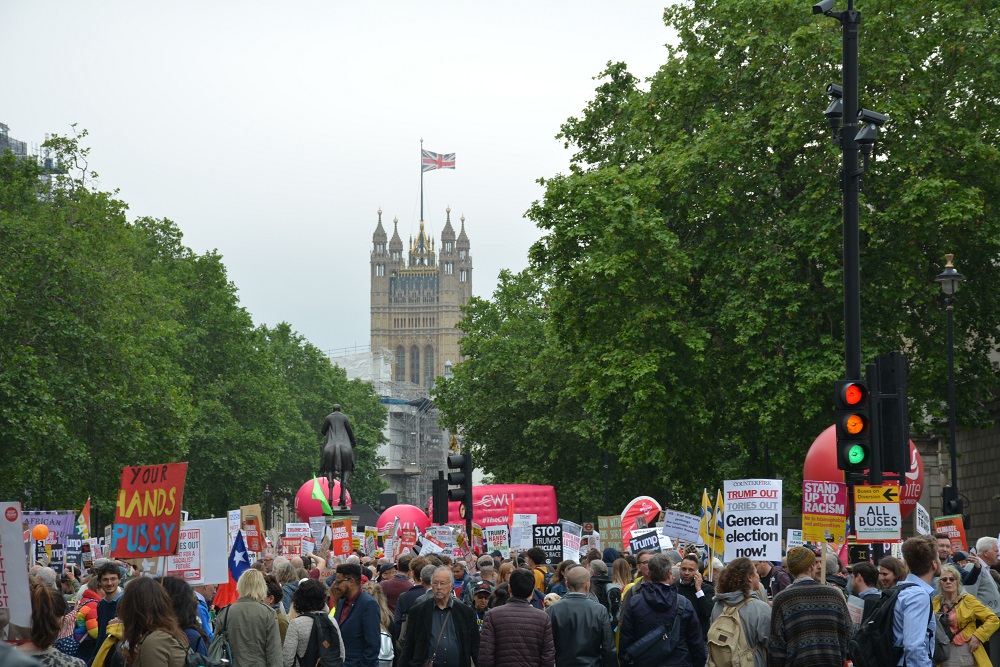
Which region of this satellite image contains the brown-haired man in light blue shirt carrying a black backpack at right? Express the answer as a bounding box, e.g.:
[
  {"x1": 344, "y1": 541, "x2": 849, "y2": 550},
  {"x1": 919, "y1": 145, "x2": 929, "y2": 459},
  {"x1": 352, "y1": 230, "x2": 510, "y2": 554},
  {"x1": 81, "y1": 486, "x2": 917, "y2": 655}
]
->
[{"x1": 892, "y1": 535, "x2": 941, "y2": 667}]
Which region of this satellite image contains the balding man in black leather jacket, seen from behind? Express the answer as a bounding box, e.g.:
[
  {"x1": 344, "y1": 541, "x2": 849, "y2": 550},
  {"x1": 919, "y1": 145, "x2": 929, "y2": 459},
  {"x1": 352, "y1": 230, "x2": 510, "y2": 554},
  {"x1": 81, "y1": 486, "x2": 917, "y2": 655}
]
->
[{"x1": 546, "y1": 567, "x2": 618, "y2": 667}]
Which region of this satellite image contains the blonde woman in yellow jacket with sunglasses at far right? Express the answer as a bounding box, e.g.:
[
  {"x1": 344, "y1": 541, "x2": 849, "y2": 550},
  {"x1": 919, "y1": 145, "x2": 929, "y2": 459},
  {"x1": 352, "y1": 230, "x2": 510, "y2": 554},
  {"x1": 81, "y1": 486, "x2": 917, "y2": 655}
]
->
[{"x1": 933, "y1": 564, "x2": 1000, "y2": 667}]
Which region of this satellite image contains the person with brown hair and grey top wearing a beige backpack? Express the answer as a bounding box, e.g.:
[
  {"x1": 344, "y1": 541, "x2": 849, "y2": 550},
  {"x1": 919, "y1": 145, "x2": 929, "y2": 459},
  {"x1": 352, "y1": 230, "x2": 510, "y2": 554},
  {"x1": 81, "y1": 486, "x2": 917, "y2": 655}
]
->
[{"x1": 708, "y1": 558, "x2": 771, "y2": 667}]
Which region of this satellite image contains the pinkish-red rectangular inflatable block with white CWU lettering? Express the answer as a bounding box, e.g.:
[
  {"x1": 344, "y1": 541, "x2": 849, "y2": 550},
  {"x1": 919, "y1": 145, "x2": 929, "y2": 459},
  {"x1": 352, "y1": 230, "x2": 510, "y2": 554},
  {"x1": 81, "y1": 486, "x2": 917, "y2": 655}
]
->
[{"x1": 427, "y1": 484, "x2": 559, "y2": 528}]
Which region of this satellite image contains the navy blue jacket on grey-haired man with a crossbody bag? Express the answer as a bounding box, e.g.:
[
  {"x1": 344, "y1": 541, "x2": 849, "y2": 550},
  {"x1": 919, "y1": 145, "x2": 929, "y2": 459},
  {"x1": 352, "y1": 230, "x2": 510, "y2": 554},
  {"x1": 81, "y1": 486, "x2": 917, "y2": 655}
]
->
[{"x1": 618, "y1": 584, "x2": 708, "y2": 667}]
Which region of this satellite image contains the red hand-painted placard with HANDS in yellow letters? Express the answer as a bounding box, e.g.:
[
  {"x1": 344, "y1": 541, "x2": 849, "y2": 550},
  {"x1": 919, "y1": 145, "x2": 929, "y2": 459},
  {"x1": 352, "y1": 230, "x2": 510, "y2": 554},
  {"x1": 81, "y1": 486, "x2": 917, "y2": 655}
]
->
[{"x1": 111, "y1": 463, "x2": 187, "y2": 558}]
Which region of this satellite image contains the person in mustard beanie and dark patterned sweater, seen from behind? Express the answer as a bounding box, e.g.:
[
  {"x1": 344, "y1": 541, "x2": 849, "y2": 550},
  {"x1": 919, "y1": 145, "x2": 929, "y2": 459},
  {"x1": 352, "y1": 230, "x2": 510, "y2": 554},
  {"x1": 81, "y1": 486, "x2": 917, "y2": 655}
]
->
[{"x1": 767, "y1": 547, "x2": 851, "y2": 667}]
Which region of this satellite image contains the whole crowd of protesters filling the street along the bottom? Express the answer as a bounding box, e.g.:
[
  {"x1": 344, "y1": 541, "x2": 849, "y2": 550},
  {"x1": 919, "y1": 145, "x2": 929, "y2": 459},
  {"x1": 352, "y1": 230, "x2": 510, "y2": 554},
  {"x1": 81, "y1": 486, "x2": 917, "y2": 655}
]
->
[{"x1": 0, "y1": 535, "x2": 1000, "y2": 667}]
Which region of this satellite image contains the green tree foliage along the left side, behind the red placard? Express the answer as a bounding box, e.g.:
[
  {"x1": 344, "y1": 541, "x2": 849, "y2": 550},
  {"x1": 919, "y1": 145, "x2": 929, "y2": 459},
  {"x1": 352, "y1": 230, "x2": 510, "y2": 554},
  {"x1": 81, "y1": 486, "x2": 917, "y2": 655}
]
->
[{"x1": 0, "y1": 133, "x2": 385, "y2": 522}]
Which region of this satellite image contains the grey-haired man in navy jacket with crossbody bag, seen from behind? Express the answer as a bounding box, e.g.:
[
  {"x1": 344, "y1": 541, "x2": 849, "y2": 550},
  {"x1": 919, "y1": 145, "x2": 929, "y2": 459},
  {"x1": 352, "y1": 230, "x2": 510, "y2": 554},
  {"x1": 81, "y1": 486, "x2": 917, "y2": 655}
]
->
[{"x1": 618, "y1": 553, "x2": 708, "y2": 667}]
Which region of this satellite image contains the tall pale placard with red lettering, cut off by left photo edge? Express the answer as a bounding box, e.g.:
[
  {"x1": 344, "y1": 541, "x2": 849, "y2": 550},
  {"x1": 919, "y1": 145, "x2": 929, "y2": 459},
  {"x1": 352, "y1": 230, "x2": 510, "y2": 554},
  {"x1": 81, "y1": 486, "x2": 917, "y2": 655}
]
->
[{"x1": 0, "y1": 502, "x2": 31, "y2": 628}]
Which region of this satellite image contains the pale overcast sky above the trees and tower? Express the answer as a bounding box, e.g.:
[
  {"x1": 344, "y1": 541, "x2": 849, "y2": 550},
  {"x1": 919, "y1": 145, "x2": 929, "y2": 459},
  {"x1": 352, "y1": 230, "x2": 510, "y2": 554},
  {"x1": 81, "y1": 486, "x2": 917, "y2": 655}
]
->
[{"x1": 0, "y1": 0, "x2": 675, "y2": 353}]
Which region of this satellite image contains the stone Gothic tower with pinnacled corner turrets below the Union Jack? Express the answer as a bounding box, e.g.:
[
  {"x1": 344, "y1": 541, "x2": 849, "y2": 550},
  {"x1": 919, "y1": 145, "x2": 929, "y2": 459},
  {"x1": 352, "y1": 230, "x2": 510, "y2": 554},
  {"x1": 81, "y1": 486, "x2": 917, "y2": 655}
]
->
[{"x1": 371, "y1": 208, "x2": 472, "y2": 390}]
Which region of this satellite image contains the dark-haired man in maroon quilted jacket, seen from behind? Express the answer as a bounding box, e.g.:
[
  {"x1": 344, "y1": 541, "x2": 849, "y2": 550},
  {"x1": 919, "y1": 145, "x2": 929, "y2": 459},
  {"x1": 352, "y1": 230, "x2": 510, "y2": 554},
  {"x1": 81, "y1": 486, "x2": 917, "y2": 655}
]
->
[{"x1": 476, "y1": 568, "x2": 556, "y2": 667}]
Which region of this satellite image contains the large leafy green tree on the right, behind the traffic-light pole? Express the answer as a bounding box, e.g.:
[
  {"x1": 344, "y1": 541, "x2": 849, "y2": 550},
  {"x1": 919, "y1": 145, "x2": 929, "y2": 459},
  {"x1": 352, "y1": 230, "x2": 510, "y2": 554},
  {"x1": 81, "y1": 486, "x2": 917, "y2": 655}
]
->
[{"x1": 449, "y1": 0, "x2": 1000, "y2": 503}]
